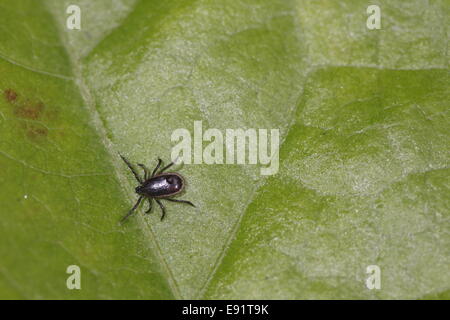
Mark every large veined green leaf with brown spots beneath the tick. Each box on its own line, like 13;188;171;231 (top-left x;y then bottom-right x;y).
0;0;450;299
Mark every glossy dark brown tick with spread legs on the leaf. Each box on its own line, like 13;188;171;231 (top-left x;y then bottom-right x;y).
119;154;195;222
